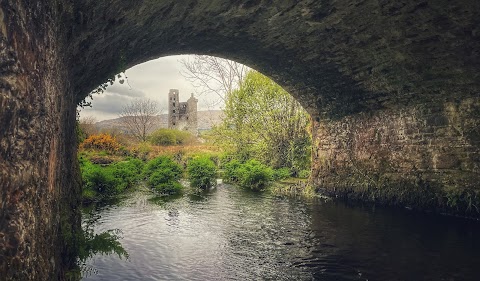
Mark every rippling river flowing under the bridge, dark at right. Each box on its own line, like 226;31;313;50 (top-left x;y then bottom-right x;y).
82;184;480;280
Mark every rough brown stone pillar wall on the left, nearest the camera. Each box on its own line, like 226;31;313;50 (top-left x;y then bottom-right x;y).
0;0;79;280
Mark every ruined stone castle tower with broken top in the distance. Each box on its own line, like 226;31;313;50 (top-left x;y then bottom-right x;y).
168;89;198;135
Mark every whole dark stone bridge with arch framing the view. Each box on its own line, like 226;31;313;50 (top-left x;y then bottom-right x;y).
0;0;480;280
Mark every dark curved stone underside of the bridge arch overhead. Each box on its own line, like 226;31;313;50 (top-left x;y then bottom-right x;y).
67;0;480;118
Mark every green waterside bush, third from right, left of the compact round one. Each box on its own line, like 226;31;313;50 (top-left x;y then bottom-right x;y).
143;156;182;195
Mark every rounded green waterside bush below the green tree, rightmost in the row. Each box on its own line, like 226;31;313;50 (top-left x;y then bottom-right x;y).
237;160;273;191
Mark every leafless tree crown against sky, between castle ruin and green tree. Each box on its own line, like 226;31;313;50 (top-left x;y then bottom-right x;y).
179;55;249;102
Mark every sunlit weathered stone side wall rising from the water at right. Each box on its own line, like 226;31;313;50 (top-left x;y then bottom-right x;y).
312;97;480;216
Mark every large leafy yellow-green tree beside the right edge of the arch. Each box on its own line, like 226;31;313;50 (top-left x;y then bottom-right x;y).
215;71;311;175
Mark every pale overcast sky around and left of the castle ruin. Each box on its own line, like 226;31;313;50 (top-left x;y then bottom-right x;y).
80;56;222;121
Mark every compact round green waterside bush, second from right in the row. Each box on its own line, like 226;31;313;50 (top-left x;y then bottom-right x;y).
187;156;217;189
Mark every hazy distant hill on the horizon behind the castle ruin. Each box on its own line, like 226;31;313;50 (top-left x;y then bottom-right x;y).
95;110;224;131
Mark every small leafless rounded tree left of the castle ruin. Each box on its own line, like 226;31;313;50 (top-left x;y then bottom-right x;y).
119;99;161;141
